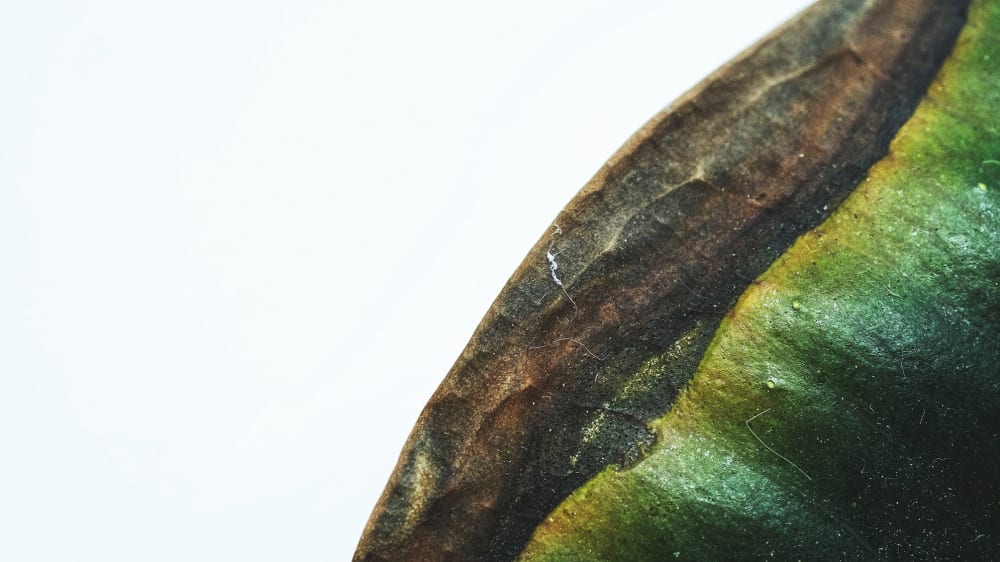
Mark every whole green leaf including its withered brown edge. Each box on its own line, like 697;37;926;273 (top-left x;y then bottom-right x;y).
355;0;1000;560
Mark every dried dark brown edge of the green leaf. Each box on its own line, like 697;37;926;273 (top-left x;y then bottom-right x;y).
355;0;969;561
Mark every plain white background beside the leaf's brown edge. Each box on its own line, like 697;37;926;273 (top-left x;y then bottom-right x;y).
0;0;807;562
